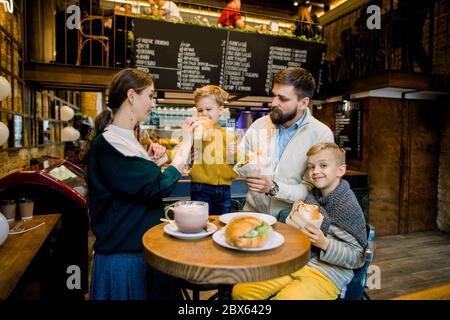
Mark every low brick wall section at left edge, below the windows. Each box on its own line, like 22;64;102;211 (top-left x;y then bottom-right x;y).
0;144;64;178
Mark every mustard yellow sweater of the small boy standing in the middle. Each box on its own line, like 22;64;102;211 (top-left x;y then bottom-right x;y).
190;124;237;186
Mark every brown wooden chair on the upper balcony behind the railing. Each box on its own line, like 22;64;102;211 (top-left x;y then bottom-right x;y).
77;16;109;67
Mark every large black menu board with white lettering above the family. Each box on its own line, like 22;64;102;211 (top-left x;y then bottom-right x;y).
134;19;325;96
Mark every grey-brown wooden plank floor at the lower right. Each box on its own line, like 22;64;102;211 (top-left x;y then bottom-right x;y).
367;231;450;300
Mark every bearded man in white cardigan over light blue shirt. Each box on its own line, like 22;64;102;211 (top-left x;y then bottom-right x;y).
239;68;334;218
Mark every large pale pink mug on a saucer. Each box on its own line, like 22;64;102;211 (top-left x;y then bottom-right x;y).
164;200;209;233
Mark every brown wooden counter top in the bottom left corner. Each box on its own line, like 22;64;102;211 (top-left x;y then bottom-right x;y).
0;214;61;300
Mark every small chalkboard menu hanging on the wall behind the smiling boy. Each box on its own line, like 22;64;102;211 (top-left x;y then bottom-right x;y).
334;101;362;160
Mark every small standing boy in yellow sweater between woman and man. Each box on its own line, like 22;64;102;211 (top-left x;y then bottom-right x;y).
190;85;237;215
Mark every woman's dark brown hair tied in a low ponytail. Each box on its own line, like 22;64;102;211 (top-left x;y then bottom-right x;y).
85;68;153;160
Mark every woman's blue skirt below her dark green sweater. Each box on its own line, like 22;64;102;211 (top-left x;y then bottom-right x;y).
90;253;182;300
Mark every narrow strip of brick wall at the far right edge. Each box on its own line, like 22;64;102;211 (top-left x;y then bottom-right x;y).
437;99;450;232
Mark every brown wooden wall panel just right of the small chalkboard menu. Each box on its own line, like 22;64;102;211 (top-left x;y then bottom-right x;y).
363;98;402;235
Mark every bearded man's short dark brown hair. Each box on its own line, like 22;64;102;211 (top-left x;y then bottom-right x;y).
273;67;316;99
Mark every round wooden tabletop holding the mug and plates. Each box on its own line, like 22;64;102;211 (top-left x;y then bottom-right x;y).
142;216;311;285
